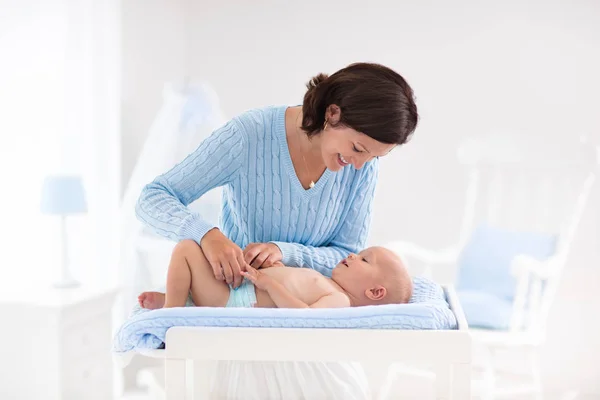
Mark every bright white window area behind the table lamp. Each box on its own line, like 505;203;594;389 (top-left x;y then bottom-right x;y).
0;0;120;284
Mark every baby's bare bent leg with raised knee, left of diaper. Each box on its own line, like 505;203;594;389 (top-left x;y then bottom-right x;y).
164;240;229;307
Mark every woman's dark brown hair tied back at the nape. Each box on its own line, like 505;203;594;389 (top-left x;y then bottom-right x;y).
302;63;419;144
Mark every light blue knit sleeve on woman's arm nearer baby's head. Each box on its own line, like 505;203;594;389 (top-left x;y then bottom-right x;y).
272;159;379;276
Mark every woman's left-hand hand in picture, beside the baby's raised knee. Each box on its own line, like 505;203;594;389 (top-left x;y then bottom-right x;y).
200;229;247;288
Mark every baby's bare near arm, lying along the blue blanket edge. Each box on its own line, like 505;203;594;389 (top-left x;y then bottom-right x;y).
242;267;350;308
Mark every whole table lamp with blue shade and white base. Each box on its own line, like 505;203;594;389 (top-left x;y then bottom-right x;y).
40;175;87;288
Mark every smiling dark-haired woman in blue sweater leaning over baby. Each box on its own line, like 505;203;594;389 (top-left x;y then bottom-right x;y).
136;63;418;287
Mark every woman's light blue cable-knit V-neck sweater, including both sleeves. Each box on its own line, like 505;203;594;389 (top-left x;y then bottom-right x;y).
136;106;378;276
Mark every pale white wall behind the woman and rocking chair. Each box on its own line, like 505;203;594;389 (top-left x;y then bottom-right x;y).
123;0;600;392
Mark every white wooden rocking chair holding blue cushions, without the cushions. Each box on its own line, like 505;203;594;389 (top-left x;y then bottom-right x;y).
388;133;599;399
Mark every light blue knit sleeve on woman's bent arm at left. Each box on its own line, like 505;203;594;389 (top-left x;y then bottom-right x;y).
135;120;247;242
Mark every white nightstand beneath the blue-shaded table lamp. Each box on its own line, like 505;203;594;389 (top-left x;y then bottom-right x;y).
0;287;117;400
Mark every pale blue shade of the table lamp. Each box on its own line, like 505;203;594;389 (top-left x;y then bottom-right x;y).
40;175;87;215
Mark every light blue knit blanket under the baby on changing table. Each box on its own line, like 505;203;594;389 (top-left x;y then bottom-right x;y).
113;278;457;354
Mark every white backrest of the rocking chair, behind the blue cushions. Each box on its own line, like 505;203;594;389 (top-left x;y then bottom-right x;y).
458;132;598;334
